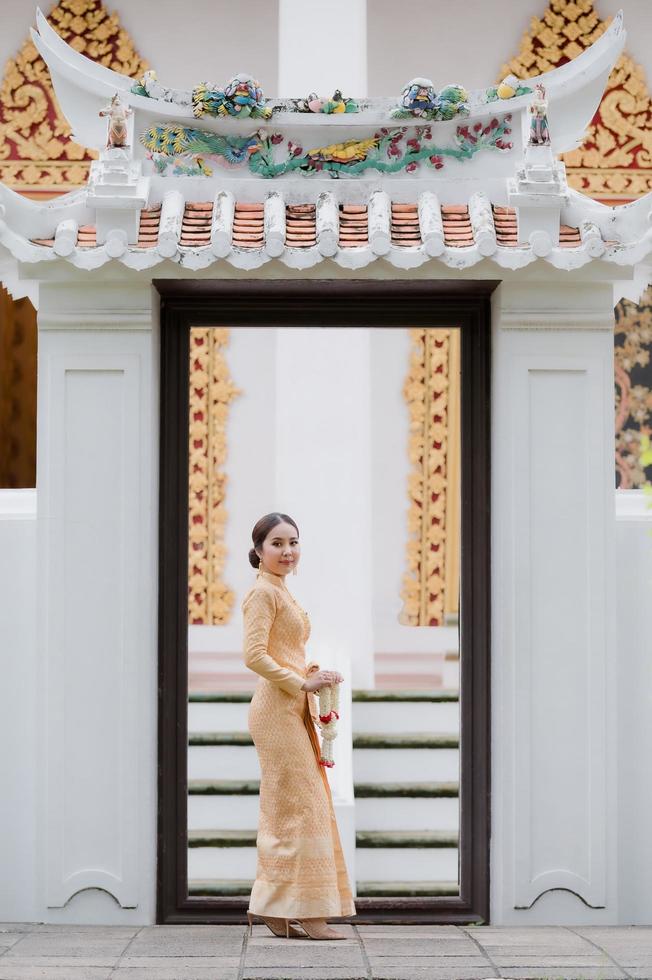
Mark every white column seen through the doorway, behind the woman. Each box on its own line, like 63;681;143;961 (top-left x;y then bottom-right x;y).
276;328;373;887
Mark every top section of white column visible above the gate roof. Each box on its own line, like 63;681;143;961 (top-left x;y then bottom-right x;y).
278;0;367;98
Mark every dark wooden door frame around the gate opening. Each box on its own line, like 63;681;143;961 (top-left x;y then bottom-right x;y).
154;280;498;924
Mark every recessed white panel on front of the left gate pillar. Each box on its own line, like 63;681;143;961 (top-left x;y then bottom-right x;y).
39;348;145;908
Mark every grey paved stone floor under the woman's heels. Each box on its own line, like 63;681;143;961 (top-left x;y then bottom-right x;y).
0;922;652;980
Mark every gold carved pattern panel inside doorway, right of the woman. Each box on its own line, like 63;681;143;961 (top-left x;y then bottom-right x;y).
399;328;457;626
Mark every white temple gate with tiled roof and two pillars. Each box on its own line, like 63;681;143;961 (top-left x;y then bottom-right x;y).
0;7;652;924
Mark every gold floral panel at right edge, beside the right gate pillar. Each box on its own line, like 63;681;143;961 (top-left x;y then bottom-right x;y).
615;286;652;490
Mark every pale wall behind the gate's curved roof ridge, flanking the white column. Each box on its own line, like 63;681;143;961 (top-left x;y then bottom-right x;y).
0;0;652;96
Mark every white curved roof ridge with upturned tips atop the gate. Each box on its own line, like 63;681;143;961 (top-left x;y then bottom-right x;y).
32;5;626;156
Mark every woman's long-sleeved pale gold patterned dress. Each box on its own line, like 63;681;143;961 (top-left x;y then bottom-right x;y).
241;571;356;919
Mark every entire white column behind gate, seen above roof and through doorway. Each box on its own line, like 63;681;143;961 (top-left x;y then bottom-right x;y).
276;0;373;892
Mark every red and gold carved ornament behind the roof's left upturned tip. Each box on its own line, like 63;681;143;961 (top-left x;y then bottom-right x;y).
0;0;149;196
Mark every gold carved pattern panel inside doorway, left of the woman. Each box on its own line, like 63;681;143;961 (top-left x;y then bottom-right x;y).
188;327;242;625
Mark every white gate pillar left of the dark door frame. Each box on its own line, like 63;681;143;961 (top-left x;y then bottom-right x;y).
35;280;158;923
